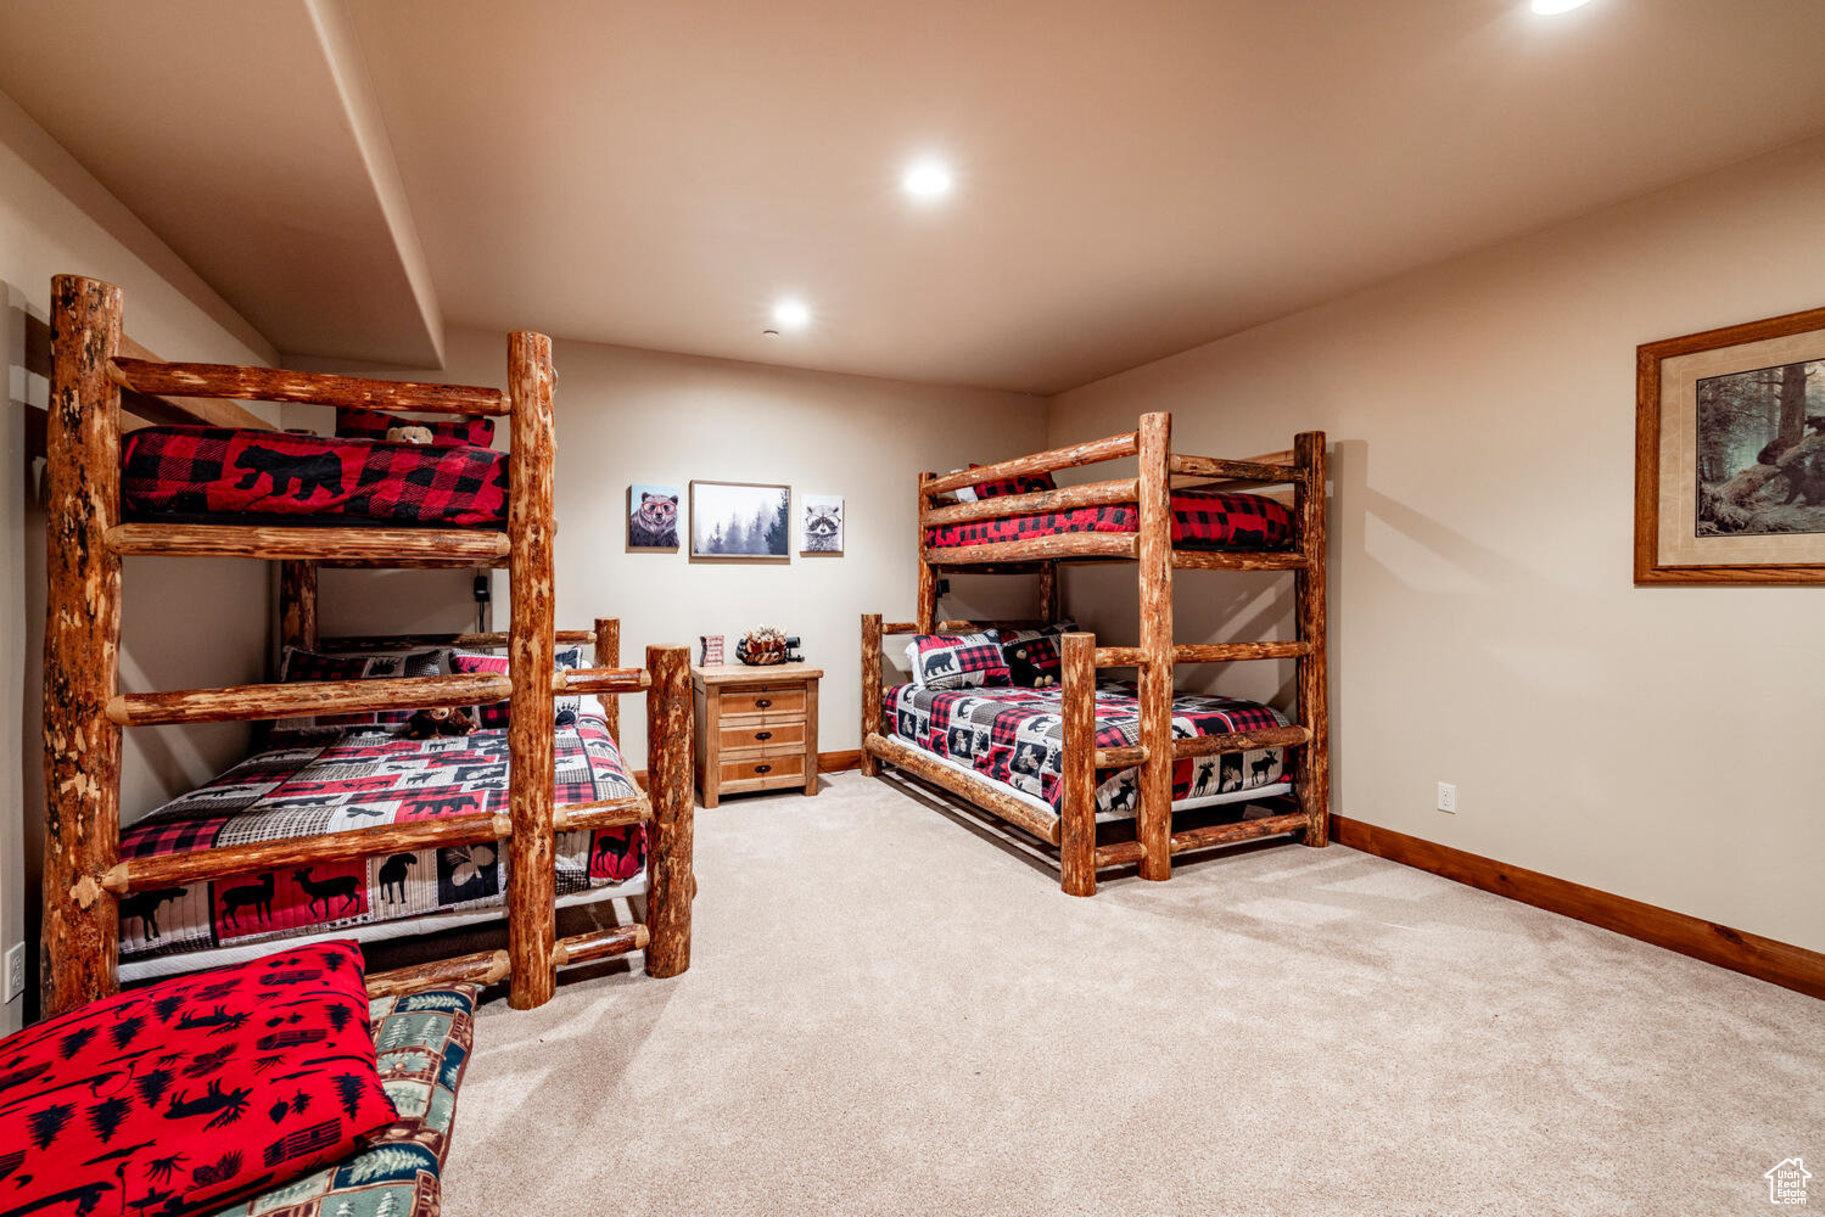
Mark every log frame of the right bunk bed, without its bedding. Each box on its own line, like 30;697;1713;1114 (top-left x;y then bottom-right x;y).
861;414;1330;896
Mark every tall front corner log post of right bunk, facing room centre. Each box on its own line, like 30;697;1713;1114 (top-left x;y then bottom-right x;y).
1135;414;1172;879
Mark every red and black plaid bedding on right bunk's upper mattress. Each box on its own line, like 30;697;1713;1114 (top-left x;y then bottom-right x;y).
925;491;1292;549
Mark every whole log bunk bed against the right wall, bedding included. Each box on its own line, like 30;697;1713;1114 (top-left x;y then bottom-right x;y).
861;414;1330;896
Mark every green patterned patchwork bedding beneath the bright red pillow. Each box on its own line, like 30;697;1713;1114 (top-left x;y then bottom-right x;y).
203;985;476;1217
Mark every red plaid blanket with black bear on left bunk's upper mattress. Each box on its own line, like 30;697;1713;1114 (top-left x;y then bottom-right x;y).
120;427;507;527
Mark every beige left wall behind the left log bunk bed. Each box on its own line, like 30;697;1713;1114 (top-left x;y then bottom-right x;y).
0;95;270;1031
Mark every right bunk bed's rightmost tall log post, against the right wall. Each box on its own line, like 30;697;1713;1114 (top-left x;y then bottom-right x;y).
1292;431;1330;845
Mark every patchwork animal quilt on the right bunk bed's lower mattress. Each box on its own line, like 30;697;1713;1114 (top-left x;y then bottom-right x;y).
881;681;1287;817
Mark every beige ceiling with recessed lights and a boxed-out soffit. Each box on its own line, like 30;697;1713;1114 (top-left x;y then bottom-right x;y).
0;0;1825;392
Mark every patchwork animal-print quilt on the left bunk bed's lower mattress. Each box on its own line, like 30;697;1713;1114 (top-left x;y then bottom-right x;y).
120;717;646;960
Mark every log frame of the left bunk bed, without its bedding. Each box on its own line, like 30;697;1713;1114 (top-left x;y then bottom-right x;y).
42;276;694;1016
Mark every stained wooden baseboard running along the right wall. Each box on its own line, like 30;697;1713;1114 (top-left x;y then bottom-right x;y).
1330;816;1825;998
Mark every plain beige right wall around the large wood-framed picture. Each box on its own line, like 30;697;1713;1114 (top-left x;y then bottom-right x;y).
1051;131;1825;949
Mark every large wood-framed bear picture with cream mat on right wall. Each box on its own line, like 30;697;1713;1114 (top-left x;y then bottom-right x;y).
1635;308;1825;584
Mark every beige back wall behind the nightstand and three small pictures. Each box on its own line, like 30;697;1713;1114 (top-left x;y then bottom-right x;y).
287;330;1046;765
